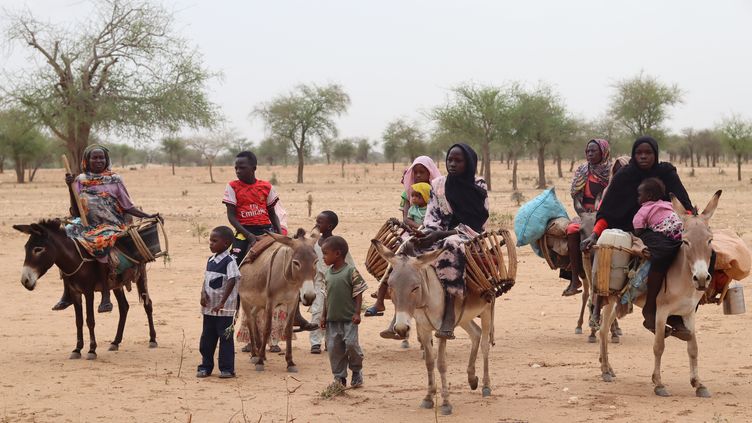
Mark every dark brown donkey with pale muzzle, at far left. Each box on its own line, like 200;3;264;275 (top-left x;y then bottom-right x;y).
13;219;157;360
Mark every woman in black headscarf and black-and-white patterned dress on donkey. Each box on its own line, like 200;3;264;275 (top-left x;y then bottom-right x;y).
417;144;488;339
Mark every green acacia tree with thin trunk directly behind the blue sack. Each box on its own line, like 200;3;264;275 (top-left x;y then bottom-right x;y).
515;85;571;189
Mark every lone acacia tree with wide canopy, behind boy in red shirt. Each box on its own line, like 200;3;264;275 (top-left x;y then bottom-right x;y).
252;84;350;184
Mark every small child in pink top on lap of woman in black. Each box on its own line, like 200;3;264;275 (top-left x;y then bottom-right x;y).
632;178;684;240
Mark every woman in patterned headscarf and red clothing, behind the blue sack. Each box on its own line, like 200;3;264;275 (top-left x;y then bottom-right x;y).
561;139;612;297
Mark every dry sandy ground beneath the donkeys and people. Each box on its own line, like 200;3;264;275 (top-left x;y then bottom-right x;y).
0;162;752;422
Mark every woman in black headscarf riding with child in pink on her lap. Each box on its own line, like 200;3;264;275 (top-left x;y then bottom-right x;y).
582;136;692;339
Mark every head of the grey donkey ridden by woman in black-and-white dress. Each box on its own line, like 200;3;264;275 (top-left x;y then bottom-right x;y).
371;239;444;336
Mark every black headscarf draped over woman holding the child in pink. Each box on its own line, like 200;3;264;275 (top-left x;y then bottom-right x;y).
597;137;692;231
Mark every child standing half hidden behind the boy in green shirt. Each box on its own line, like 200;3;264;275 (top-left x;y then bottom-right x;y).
308;210;355;354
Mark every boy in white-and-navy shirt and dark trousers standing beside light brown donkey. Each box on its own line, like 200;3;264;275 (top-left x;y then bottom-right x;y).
196;226;240;378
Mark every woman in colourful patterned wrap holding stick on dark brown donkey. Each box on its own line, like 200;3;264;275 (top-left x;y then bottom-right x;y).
52;144;159;313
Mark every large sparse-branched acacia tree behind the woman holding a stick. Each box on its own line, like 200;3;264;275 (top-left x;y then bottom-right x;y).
2;0;216;171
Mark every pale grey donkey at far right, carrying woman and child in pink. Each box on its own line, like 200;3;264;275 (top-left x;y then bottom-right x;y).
600;191;721;398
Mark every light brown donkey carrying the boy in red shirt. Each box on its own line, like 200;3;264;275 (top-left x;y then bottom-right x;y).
238;229;318;373
